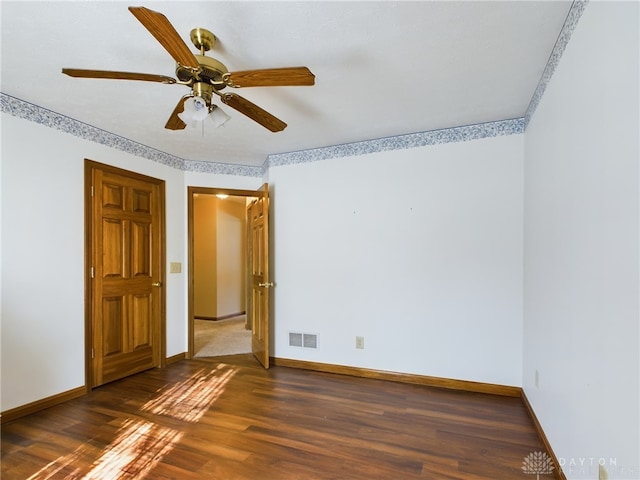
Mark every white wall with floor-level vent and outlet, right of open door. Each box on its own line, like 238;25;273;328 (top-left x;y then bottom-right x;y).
269;135;523;385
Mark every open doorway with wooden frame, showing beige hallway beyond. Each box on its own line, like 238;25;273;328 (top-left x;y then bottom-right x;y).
188;187;257;358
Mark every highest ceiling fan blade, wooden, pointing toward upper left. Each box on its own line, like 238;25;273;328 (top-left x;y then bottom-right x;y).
129;7;200;69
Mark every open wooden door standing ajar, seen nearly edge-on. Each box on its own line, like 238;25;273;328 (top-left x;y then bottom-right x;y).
247;183;273;368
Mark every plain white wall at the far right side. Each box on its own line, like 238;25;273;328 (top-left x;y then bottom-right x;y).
523;2;640;479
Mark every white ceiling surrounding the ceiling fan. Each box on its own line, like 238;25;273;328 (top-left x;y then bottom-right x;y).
0;1;571;166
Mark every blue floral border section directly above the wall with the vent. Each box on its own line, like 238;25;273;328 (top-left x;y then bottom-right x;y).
265;118;524;168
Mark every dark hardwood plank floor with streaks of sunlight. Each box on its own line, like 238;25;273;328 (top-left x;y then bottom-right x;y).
1;355;551;480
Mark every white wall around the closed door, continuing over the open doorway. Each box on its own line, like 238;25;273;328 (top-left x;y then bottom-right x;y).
0;113;261;411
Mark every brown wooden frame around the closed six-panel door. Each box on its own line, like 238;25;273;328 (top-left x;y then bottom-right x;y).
84;158;167;393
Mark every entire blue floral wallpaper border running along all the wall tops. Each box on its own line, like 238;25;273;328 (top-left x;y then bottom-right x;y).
0;0;589;177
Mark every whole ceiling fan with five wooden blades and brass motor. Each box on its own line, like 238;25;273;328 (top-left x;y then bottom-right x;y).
62;7;315;132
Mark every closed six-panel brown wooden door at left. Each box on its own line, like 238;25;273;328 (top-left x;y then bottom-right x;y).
89;164;164;386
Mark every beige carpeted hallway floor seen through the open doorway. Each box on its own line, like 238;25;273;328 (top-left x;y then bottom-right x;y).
194;315;251;357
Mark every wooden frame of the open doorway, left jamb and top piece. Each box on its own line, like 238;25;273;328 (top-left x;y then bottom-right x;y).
186;187;263;358
